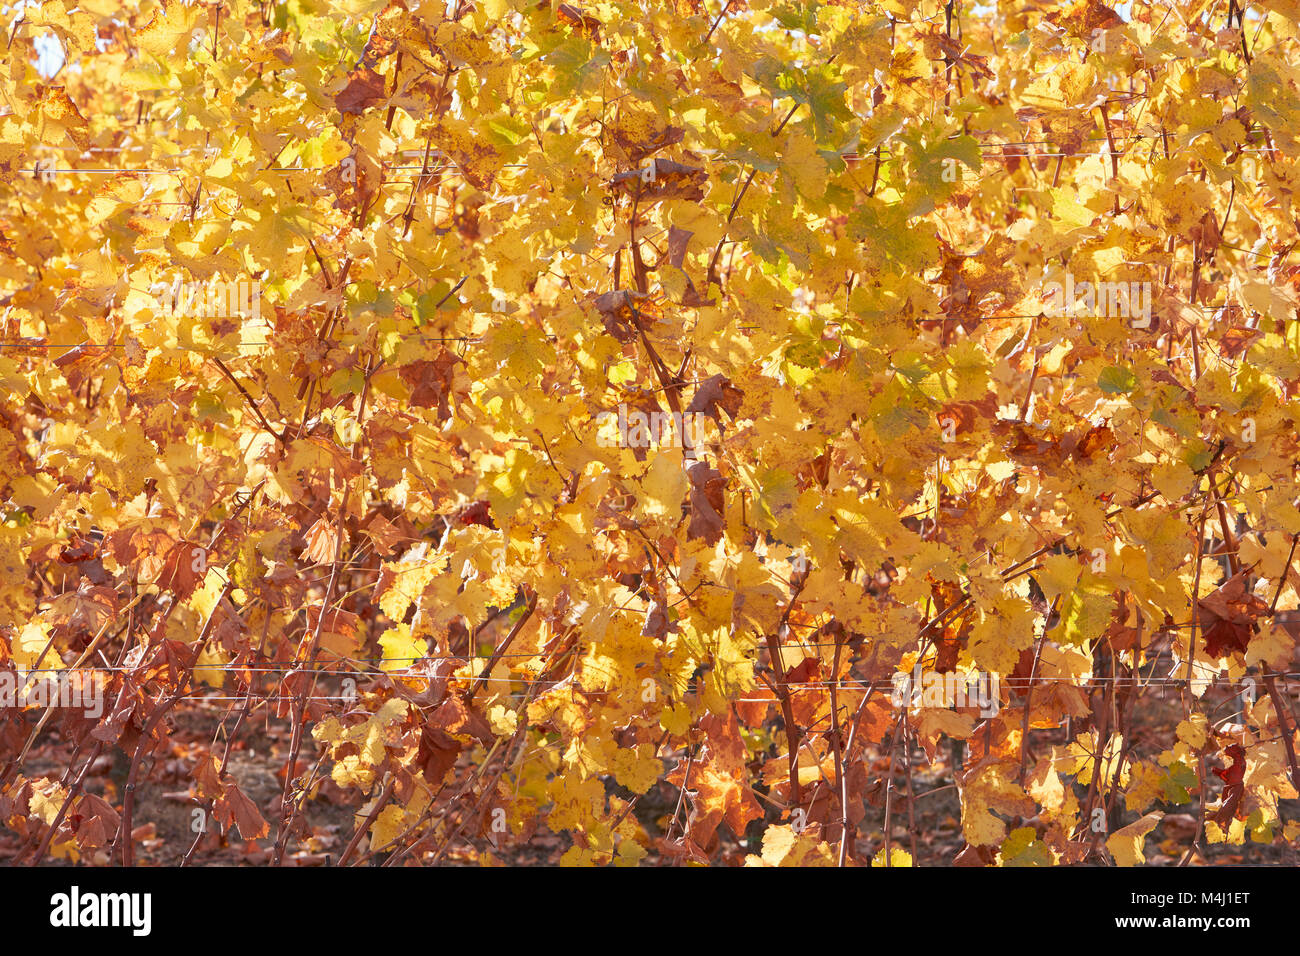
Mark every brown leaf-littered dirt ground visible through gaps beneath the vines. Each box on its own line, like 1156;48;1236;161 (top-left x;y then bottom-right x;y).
0;671;1300;866
